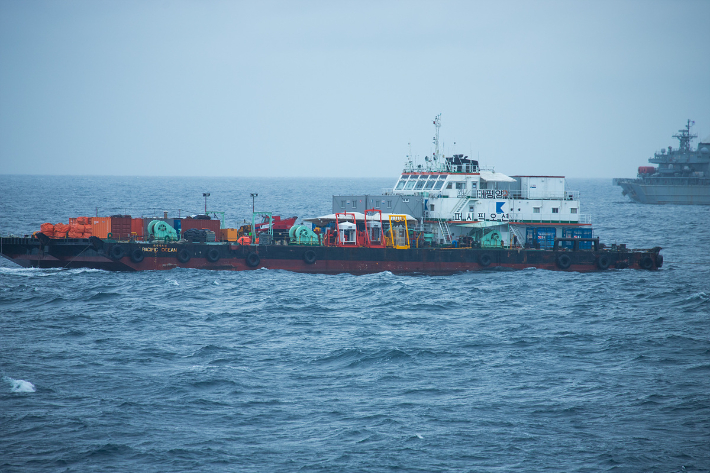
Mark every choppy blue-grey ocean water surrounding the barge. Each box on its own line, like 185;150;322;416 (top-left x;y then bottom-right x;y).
0;175;710;473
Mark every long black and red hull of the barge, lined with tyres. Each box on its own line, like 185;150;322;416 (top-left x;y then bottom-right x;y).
3;239;663;275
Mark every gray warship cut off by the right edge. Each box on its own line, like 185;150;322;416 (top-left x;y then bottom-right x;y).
613;120;710;205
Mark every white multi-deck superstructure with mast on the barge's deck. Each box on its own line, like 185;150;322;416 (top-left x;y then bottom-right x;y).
387;116;591;247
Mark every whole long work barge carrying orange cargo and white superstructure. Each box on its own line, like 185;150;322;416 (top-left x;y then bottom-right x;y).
0;115;663;274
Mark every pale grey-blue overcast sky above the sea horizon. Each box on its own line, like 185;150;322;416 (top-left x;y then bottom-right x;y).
0;0;710;178
